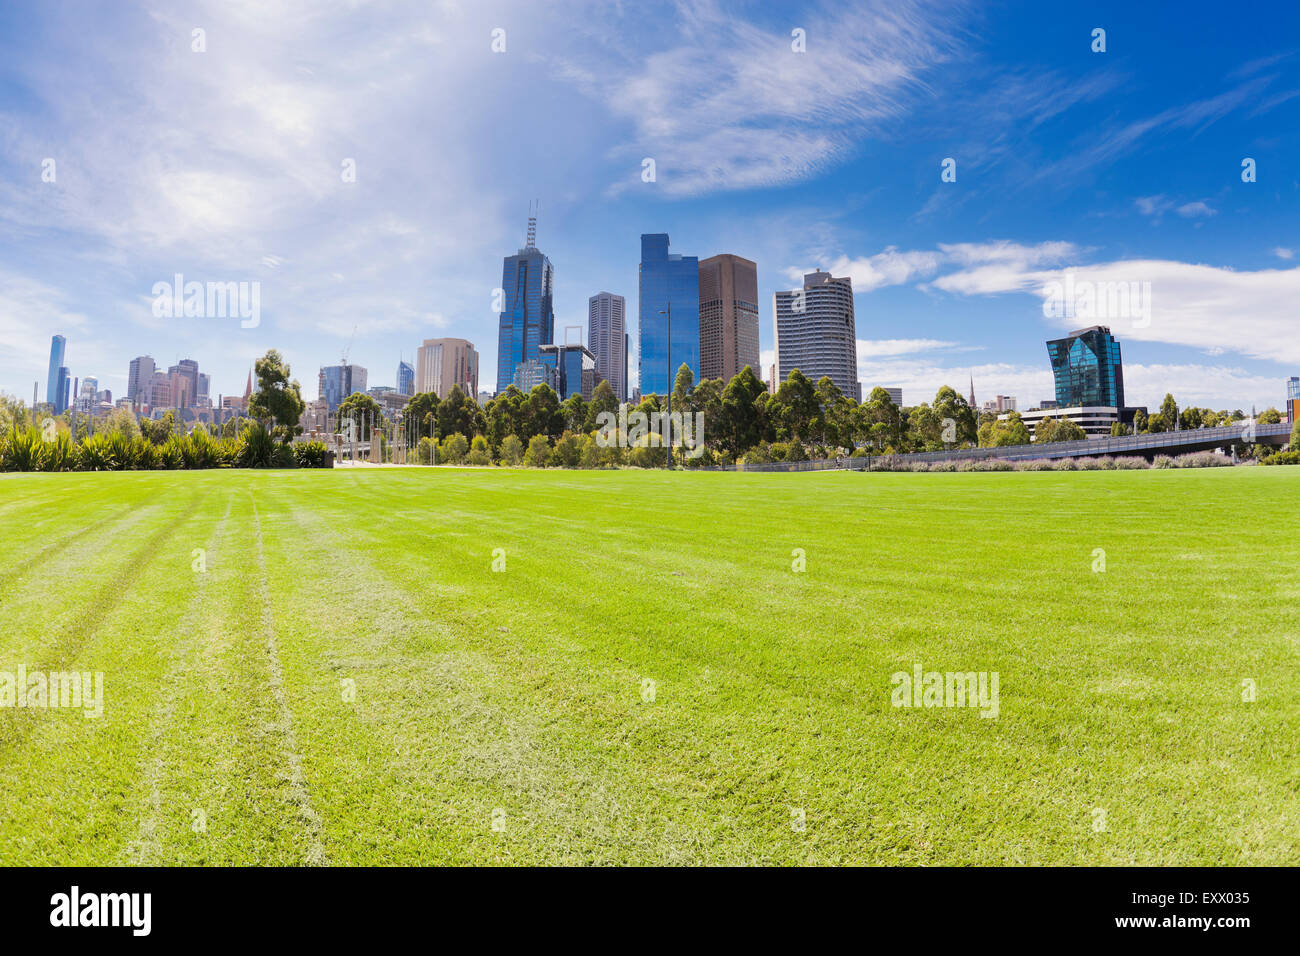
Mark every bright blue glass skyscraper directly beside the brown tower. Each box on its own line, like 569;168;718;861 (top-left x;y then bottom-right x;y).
637;233;699;395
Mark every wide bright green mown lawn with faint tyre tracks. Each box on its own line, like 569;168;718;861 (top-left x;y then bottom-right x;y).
0;468;1300;865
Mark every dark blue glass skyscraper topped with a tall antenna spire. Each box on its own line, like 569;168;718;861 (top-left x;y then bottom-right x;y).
496;216;555;393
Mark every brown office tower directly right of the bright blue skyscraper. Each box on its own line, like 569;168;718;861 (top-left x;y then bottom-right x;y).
699;254;762;382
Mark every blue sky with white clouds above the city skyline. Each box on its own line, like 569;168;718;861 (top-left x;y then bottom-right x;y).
0;0;1300;408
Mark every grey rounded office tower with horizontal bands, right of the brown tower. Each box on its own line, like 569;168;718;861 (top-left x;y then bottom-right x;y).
772;269;859;398
